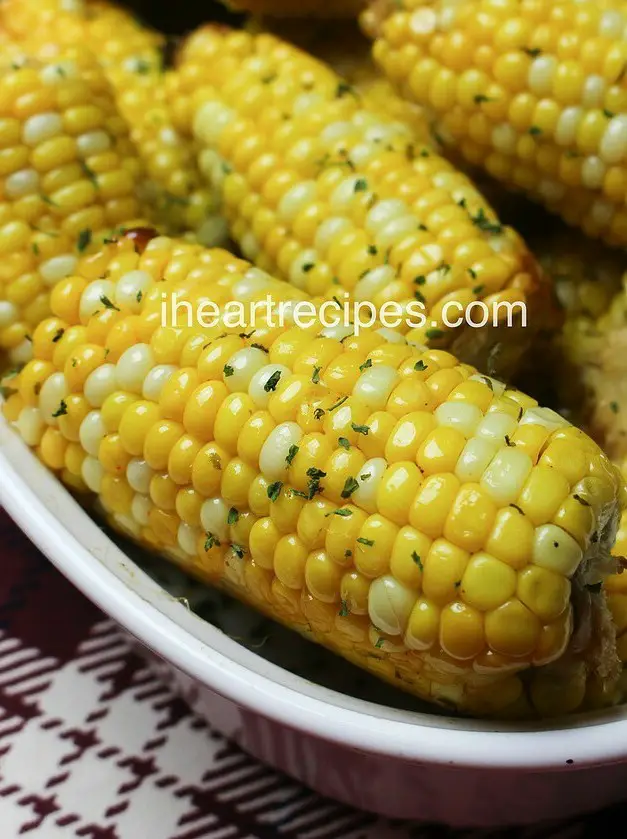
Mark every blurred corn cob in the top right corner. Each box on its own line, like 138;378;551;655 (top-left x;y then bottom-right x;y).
364;0;627;246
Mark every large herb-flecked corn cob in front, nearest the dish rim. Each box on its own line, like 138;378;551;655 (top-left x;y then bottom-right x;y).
5;226;622;716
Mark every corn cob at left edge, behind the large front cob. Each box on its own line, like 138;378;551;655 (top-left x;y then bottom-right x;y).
0;45;145;363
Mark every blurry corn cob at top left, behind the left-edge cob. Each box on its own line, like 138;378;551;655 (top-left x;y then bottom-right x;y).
3;0;225;245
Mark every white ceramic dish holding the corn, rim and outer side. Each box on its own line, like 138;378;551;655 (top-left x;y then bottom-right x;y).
0;420;627;826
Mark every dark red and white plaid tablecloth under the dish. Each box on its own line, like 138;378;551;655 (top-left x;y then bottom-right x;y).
0;511;627;839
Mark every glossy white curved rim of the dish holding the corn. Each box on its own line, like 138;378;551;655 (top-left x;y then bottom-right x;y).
0;417;627;771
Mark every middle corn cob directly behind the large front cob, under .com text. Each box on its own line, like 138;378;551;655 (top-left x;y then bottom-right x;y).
172;27;550;372
